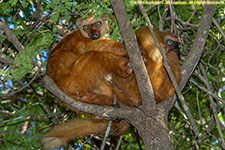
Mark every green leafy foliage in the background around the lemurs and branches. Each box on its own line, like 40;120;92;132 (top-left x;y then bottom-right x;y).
0;0;225;150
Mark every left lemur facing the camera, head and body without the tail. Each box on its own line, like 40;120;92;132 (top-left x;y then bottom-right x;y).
46;14;132;111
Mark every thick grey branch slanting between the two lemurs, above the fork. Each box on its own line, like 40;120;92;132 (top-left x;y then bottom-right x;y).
111;0;156;110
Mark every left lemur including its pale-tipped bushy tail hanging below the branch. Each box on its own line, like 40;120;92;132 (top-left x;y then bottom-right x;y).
40;15;132;150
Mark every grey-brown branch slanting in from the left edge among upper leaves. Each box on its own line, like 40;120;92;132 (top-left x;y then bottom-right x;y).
0;21;24;52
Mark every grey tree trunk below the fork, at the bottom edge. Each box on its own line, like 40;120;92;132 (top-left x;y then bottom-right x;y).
132;107;173;150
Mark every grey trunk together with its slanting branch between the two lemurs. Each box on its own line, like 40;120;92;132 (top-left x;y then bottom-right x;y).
111;0;173;149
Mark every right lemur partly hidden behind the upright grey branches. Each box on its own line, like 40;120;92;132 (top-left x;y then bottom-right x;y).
114;26;181;106
